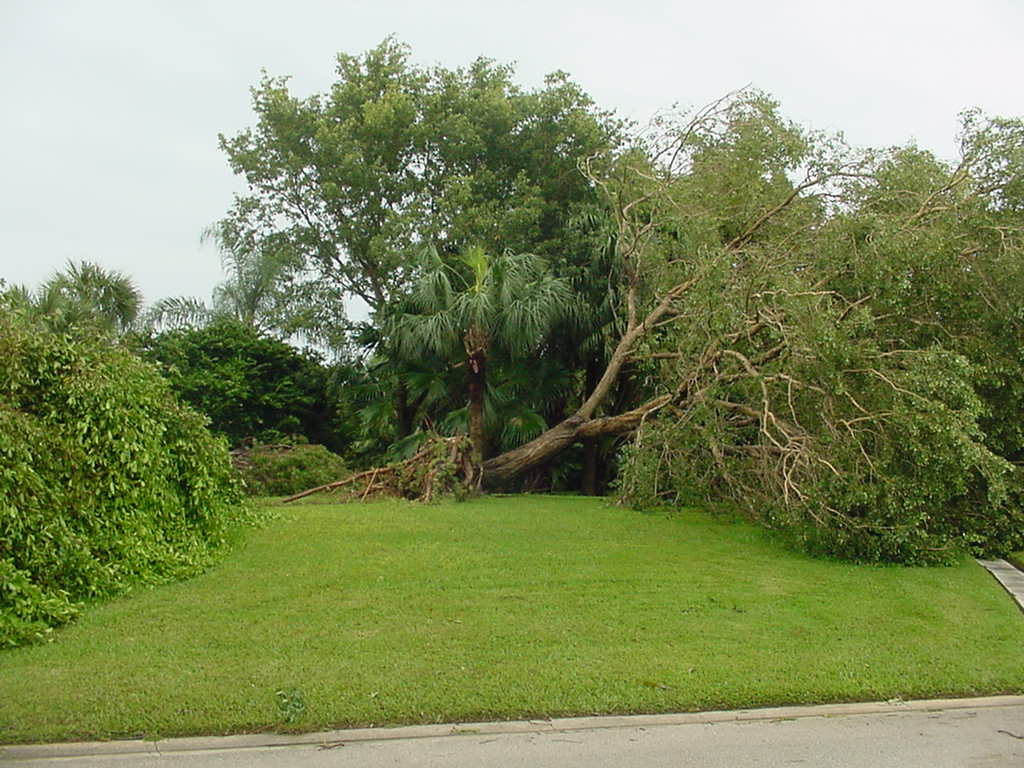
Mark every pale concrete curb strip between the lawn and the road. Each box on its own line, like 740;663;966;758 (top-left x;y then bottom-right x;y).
0;695;1024;763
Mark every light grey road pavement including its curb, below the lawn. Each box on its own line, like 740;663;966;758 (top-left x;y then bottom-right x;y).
0;696;1024;768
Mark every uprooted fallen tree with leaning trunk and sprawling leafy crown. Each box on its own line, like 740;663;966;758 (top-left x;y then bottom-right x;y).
282;93;1024;562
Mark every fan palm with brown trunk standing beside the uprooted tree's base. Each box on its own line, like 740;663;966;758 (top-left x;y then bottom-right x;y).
387;246;573;461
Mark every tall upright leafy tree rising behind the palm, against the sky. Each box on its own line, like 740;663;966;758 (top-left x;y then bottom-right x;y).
218;39;621;438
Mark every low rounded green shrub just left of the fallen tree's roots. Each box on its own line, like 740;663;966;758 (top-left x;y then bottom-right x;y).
234;444;349;496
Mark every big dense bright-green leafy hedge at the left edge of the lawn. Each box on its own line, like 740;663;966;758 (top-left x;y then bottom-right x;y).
0;310;247;647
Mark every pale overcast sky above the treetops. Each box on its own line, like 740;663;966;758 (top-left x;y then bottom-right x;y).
0;0;1024;309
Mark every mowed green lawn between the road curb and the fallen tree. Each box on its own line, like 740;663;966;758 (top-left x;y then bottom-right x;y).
0;497;1024;742
